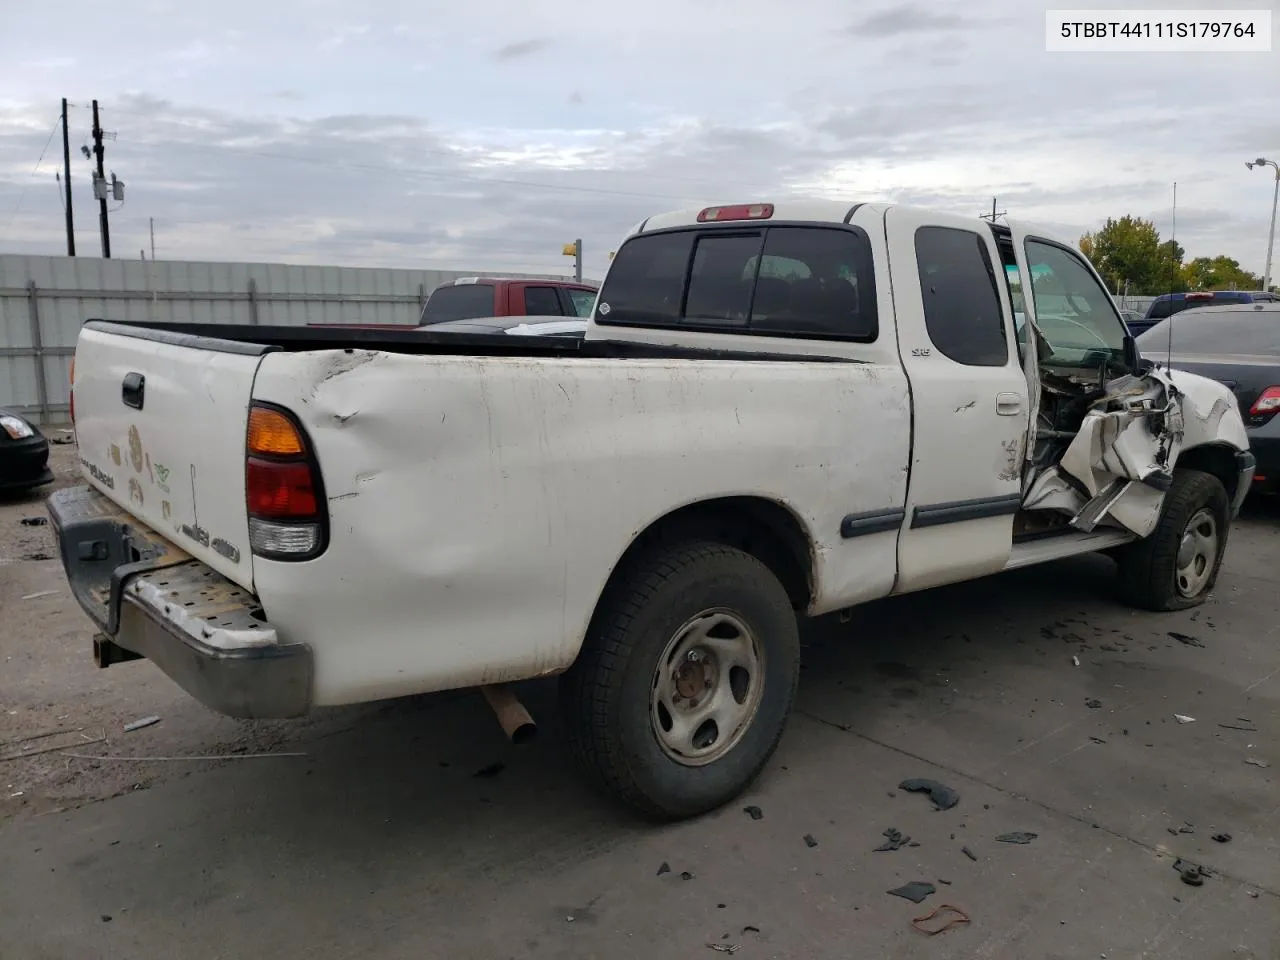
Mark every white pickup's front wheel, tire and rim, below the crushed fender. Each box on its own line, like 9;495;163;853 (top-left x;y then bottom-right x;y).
1116;470;1230;612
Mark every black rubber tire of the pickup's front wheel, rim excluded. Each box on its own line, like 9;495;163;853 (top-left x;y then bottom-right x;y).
1116;470;1231;612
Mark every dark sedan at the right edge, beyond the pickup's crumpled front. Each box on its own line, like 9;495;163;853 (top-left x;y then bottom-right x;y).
1137;302;1280;493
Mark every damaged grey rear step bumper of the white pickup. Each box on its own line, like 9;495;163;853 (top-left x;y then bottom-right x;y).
47;486;314;719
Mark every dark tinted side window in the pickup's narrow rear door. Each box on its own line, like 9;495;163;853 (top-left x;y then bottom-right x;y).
915;227;1009;366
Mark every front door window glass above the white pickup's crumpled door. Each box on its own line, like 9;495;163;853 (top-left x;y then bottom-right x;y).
1025;239;1125;367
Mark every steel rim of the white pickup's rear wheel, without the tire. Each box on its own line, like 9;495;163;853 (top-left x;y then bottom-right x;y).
649;609;764;767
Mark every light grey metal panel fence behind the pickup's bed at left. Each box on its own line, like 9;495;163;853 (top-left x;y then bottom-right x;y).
0;253;568;424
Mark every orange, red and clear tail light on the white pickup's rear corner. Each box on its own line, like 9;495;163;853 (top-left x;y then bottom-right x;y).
244;403;329;561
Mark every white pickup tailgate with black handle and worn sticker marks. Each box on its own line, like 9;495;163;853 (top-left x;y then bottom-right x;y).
74;321;270;589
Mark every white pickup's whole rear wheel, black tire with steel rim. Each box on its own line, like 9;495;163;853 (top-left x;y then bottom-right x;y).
561;543;800;819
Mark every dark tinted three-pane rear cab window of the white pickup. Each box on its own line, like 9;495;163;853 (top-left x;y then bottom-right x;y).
596;227;877;342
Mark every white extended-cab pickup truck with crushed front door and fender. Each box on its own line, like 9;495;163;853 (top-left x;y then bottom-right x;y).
49;201;1253;818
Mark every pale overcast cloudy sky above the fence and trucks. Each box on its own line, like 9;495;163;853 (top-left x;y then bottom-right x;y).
0;0;1280;276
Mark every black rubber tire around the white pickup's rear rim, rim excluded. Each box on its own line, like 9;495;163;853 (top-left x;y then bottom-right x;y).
561;541;800;819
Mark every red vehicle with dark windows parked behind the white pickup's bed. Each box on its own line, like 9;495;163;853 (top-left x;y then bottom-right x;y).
419;276;596;325
